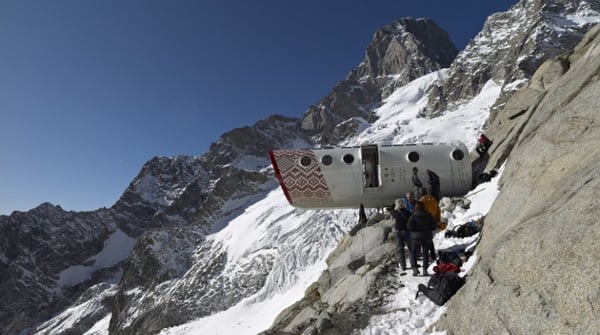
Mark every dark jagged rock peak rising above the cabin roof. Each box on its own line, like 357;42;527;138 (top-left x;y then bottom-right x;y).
302;19;458;145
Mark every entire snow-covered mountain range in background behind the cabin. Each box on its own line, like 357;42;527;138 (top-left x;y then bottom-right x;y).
0;0;600;334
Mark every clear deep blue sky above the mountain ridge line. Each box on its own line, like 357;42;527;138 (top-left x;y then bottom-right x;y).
0;0;517;214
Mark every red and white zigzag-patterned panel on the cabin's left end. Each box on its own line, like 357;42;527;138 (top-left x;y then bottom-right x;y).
271;150;333;206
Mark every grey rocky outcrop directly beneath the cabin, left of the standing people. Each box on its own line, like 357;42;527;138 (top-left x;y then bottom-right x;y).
262;217;402;335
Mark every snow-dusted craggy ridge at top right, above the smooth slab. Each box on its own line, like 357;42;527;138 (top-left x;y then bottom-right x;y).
424;0;600;120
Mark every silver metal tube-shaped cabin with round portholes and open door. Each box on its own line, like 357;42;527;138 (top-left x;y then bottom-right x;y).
269;143;471;209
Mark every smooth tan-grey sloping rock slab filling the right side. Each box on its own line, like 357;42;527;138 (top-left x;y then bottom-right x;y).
437;26;600;334
